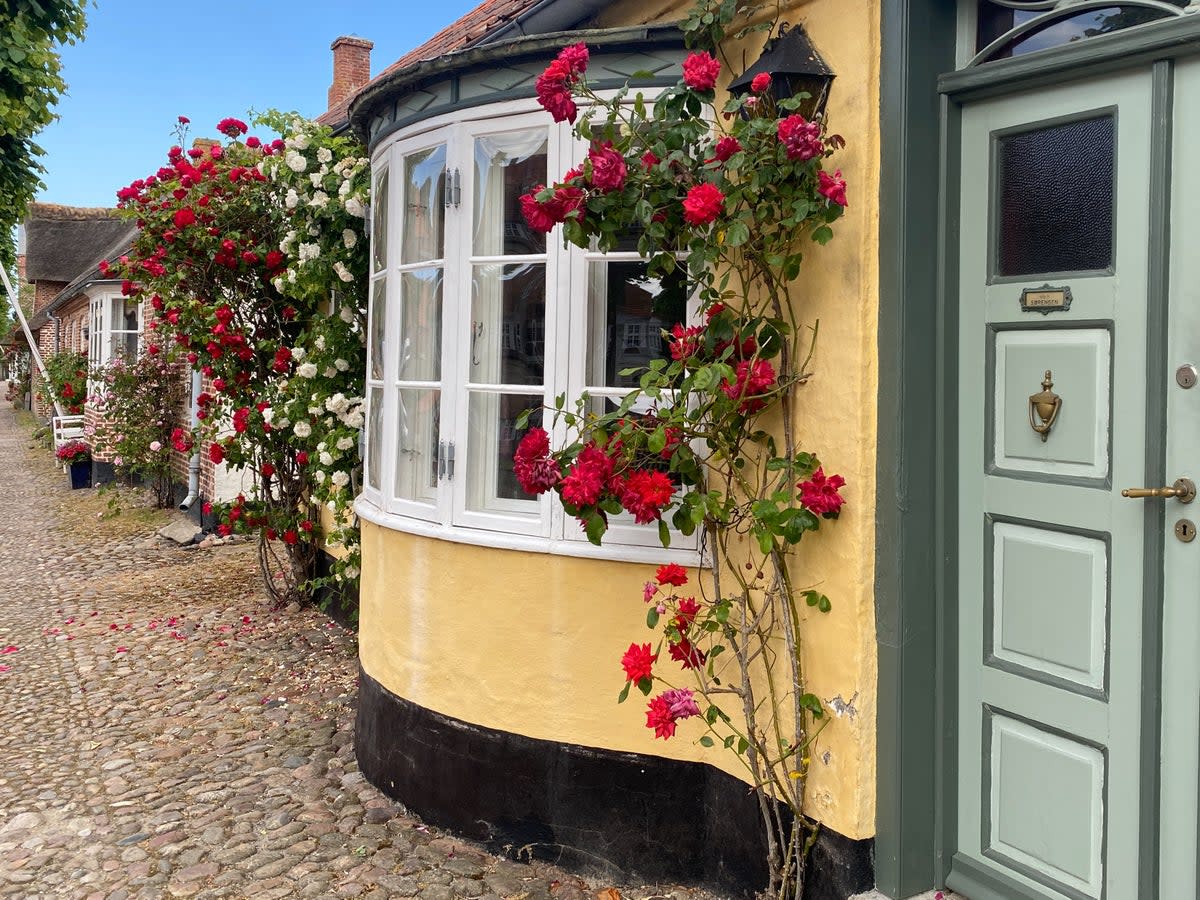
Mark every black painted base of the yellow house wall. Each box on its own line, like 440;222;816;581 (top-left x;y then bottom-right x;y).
355;672;875;900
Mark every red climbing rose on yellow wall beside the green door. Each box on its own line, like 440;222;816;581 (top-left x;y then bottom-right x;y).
514;0;847;898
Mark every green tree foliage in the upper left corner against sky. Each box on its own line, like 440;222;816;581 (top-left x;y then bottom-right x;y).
0;0;86;265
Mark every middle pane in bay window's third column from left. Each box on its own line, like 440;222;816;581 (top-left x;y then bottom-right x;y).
470;263;546;384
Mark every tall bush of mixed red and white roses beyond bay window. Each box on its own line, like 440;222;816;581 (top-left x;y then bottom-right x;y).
105;113;368;602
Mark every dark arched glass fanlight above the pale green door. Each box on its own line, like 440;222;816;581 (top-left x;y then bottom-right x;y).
970;0;1200;66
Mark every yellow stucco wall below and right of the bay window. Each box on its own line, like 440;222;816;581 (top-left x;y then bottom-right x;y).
360;0;880;839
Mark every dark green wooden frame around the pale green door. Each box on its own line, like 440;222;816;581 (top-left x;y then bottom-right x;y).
875;8;1200;898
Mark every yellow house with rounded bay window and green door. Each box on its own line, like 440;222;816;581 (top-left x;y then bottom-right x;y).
348;0;1200;900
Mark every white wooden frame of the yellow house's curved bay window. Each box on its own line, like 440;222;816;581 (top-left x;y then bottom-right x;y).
356;101;698;564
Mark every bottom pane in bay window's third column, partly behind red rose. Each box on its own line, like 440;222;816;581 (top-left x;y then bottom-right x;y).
466;391;542;515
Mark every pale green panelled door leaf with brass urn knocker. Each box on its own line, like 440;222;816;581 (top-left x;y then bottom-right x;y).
949;67;1156;900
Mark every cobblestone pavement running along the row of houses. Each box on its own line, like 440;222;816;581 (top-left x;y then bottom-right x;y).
0;409;712;900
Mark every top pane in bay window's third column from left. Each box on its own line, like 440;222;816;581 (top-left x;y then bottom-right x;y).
473;128;546;257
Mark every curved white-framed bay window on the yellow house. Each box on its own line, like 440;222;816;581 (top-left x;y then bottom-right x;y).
362;106;695;557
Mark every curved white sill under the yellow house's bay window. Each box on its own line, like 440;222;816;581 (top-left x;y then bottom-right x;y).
354;494;702;566
